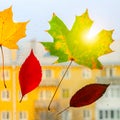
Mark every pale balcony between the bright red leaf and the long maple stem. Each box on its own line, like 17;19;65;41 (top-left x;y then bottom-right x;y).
40;78;59;86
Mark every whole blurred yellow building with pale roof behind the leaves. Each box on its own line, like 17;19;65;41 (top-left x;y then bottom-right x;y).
0;41;120;120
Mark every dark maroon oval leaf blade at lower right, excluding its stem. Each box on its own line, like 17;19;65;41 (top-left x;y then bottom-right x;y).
70;84;109;107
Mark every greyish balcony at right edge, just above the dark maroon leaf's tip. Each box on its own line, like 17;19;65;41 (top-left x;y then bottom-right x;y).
96;76;120;85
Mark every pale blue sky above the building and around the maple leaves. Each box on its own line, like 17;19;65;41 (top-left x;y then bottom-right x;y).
0;0;120;64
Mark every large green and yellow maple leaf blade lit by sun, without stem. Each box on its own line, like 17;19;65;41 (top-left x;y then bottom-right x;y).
41;10;113;69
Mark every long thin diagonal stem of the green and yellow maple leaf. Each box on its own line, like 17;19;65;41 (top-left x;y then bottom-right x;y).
48;60;73;111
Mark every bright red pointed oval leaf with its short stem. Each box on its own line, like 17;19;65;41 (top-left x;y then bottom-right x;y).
19;50;42;101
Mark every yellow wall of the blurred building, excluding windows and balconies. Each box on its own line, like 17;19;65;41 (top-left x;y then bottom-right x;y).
0;65;104;120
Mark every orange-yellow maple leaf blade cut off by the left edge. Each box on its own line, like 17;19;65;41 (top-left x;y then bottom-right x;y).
0;7;28;49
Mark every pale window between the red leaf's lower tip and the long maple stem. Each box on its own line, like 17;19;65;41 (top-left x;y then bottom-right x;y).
40;90;52;100
